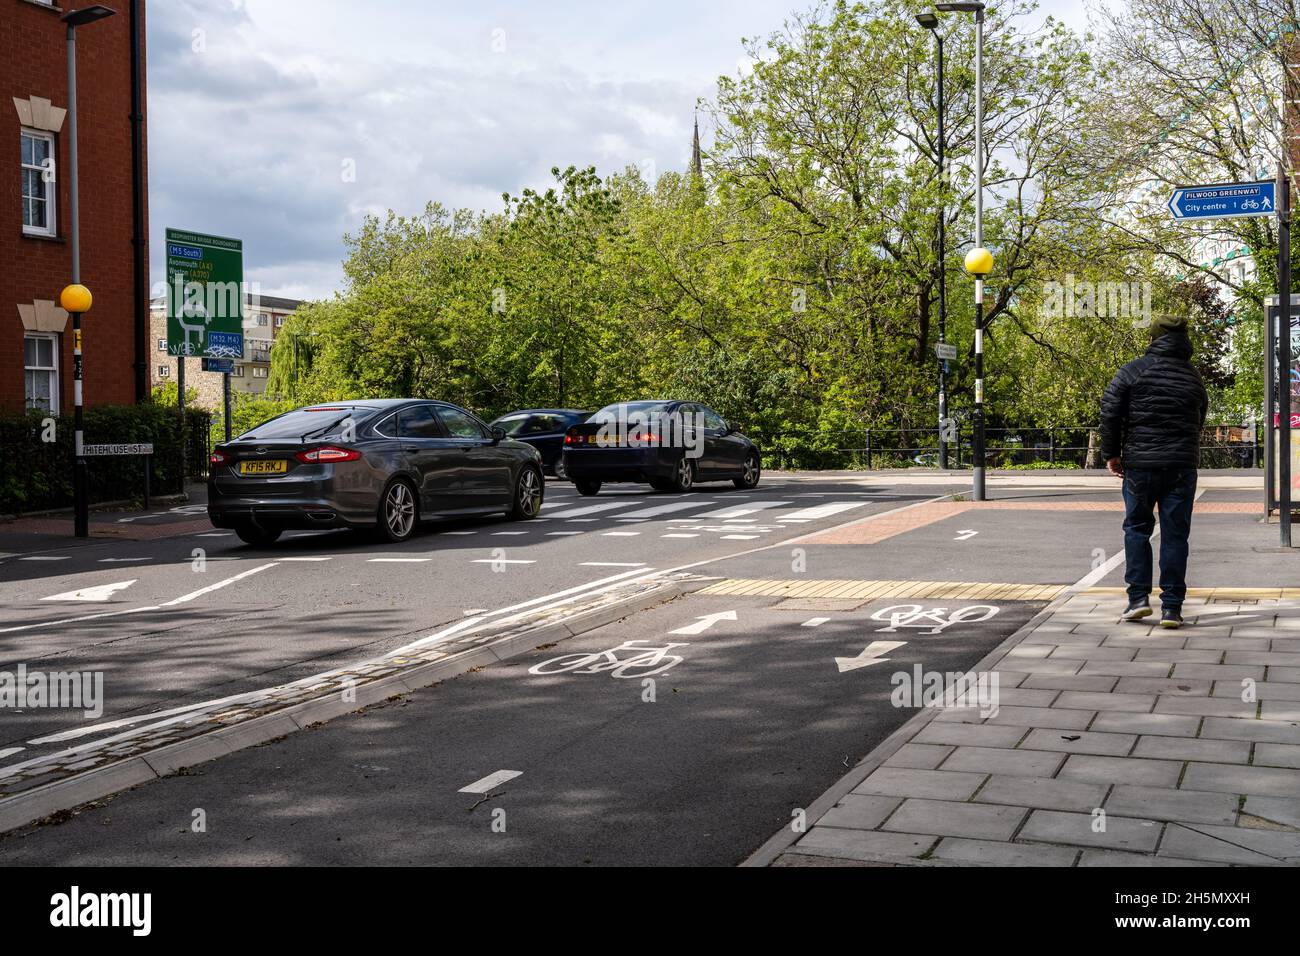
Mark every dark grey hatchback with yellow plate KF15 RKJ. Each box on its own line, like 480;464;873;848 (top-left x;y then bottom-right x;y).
208;398;545;545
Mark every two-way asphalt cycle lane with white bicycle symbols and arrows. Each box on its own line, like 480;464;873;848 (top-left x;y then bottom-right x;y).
0;596;1040;865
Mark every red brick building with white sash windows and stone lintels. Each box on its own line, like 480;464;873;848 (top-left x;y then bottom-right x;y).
0;0;150;414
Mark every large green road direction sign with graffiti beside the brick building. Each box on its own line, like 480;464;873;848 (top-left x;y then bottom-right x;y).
166;229;243;359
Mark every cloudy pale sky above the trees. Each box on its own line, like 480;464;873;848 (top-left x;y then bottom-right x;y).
148;0;1107;298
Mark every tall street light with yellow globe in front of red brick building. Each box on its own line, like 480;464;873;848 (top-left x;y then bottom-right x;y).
59;4;114;537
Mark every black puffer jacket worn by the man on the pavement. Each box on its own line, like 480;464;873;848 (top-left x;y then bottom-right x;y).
1101;332;1209;468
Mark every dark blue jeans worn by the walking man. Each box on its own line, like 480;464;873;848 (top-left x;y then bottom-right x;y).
1125;467;1196;611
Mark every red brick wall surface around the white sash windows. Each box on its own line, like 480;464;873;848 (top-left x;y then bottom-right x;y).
0;0;151;411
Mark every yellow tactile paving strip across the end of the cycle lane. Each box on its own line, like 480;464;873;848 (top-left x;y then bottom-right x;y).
698;578;1071;602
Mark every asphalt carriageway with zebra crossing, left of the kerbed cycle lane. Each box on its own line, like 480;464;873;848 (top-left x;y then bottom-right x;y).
0;476;944;767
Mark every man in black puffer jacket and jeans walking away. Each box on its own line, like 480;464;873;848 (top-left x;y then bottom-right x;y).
1101;316;1209;627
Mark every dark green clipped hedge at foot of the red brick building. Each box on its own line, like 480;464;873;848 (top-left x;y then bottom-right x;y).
0;402;209;514
